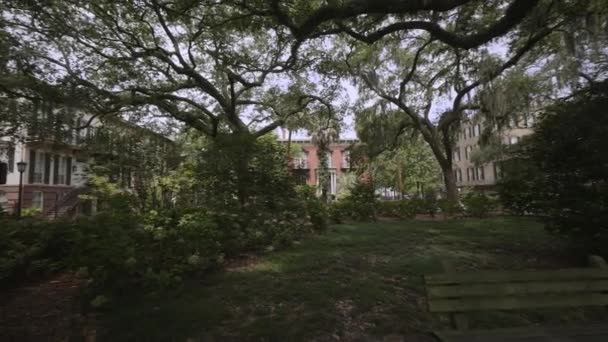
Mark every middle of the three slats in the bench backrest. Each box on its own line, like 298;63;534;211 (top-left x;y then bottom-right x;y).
427;280;608;299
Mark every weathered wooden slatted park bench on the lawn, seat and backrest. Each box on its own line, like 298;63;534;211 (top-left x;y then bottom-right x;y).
424;256;608;342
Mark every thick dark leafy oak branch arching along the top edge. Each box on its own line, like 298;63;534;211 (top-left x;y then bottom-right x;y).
245;0;540;49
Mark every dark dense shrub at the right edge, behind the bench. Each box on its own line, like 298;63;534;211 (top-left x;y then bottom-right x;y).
501;81;608;245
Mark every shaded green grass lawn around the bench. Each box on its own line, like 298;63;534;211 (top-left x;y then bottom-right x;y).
102;218;605;341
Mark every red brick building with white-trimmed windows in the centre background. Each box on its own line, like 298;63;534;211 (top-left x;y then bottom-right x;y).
283;139;358;196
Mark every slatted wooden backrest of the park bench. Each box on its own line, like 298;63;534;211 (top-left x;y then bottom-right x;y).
424;268;608;313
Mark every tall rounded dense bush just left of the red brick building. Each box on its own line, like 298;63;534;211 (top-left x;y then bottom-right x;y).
173;134;318;250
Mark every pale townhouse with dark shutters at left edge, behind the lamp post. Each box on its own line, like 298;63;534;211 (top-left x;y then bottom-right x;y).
0;110;92;212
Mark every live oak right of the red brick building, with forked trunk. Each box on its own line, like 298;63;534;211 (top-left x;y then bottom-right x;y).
298;1;600;201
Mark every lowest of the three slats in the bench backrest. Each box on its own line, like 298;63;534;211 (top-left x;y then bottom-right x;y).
428;293;608;312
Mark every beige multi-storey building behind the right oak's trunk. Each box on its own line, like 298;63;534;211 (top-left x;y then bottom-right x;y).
452;116;534;188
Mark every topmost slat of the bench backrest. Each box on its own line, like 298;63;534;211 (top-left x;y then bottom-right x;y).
424;268;608;285
